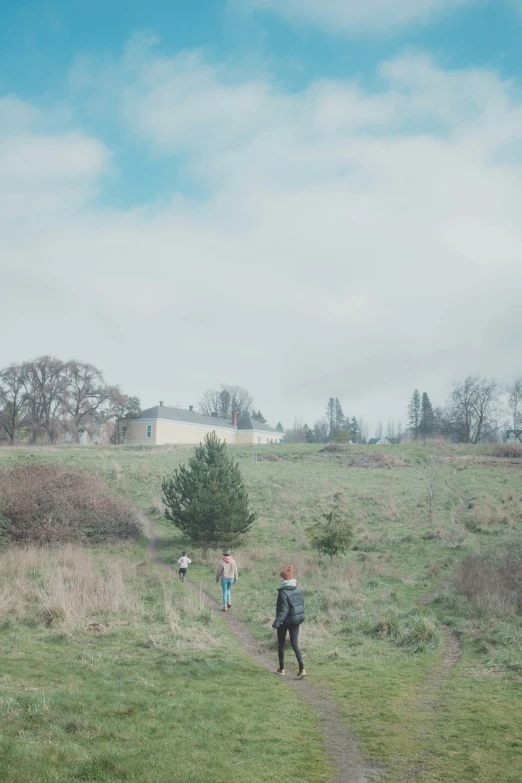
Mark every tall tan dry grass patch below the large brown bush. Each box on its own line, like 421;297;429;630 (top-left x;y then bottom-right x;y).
0;544;217;650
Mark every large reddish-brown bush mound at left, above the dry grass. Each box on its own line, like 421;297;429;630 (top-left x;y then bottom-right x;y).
0;463;141;543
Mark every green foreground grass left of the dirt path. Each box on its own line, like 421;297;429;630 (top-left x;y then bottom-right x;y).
0;544;329;783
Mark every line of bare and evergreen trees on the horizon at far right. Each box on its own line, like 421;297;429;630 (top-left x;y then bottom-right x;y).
408;374;522;443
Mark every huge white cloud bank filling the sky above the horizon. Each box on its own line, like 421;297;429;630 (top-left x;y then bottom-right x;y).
0;48;522;434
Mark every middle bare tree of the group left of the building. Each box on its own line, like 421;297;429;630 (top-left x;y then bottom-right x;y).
22;356;67;443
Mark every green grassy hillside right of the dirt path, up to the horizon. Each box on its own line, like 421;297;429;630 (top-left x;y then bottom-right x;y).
0;446;522;783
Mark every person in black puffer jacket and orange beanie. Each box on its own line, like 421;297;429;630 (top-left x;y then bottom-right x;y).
272;566;306;680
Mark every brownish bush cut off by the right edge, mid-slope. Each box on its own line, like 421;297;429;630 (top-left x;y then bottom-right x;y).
455;544;522;614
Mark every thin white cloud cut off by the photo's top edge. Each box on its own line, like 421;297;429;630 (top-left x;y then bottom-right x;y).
238;0;476;33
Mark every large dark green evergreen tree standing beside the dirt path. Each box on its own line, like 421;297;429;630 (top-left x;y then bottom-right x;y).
162;432;257;549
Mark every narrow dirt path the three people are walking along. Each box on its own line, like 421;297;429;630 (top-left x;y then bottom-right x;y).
136;509;383;783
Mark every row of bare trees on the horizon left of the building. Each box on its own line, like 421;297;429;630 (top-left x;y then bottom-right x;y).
0;356;134;444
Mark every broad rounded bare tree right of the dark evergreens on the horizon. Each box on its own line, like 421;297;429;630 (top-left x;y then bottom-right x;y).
447;375;502;443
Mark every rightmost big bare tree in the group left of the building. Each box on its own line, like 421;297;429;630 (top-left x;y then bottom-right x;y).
61;360;125;443
